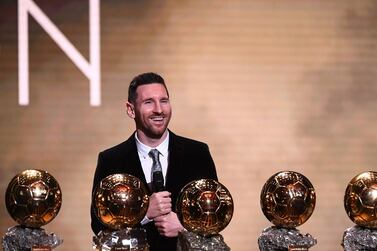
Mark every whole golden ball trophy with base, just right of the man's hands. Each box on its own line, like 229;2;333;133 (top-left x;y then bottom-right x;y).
176;179;233;251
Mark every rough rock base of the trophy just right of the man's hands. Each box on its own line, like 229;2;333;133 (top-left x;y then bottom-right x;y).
177;230;230;251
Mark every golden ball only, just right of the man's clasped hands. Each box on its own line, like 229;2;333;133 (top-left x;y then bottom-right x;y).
176;179;233;236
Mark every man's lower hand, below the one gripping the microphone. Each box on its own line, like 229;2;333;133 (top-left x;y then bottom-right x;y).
154;212;183;237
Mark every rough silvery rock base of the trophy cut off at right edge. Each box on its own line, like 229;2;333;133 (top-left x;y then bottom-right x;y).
341;226;377;251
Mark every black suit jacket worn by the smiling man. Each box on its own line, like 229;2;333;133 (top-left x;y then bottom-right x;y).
91;131;217;251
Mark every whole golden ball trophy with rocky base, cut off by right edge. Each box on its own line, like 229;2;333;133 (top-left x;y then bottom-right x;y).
342;171;377;251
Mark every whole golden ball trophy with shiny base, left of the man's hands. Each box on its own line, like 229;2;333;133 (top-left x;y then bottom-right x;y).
93;174;149;251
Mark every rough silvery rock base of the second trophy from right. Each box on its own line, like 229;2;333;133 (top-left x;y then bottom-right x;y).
258;226;317;251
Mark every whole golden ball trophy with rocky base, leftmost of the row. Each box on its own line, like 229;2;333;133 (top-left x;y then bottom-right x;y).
3;169;63;251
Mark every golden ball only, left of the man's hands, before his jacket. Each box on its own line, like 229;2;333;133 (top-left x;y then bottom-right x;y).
94;174;149;230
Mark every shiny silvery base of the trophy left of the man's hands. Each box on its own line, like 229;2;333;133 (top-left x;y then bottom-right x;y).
93;228;149;251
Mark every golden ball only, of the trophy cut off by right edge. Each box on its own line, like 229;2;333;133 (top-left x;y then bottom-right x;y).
344;171;377;229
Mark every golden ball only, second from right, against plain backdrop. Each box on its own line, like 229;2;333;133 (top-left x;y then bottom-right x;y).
260;171;316;228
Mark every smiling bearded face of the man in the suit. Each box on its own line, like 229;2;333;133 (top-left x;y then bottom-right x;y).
127;83;171;139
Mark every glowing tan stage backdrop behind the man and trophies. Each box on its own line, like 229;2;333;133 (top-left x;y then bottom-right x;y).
0;0;377;251
